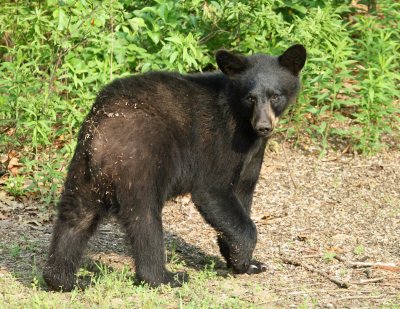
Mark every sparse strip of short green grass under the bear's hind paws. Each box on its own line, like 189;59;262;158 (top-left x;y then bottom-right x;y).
0;267;274;308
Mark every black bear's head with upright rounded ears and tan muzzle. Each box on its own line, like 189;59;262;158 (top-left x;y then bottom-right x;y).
216;44;307;137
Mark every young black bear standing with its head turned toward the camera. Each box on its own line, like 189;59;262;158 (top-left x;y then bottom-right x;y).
43;45;306;291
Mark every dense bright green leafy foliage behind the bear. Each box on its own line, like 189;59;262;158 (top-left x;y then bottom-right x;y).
0;0;400;201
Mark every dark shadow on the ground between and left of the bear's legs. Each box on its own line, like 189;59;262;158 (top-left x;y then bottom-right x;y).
0;221;231;290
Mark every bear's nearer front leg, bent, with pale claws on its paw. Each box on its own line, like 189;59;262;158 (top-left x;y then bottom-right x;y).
192;190;266;274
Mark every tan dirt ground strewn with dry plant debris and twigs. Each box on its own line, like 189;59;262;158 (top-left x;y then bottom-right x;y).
0;144;400;308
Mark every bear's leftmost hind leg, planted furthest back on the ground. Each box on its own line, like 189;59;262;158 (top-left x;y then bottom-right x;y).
43;194;101;291
